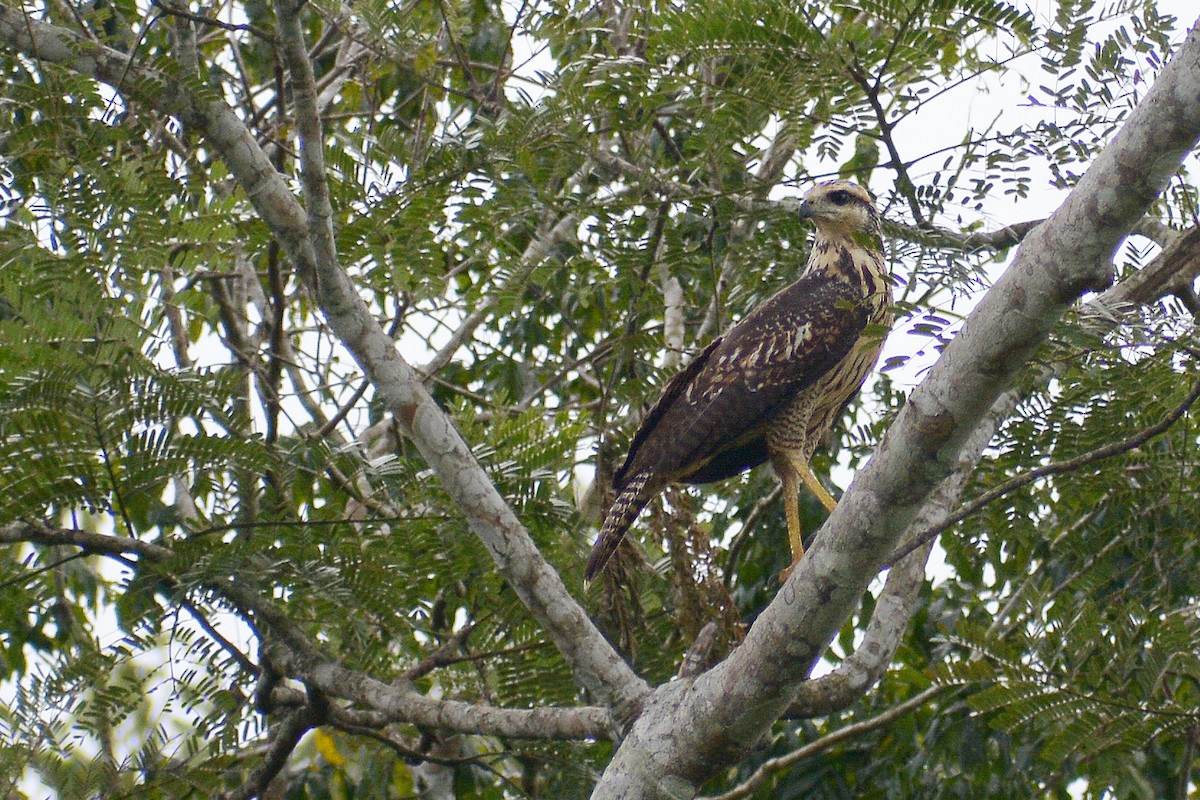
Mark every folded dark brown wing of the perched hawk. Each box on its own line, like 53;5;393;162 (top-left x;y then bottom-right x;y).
613;273;866;492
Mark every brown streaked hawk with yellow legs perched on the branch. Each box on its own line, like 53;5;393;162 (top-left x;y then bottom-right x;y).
584;181;892;581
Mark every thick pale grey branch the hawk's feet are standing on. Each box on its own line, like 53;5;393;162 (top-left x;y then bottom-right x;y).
593;15;1200;799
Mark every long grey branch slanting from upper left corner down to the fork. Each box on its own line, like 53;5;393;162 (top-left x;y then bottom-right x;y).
0;6;647;717
